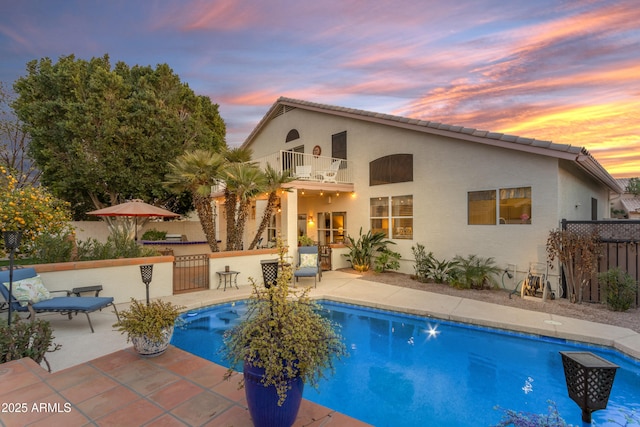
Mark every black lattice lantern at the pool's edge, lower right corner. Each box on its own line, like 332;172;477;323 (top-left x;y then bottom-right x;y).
560;351;618;423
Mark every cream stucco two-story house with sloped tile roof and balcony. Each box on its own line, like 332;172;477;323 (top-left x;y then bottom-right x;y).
243;98;622;286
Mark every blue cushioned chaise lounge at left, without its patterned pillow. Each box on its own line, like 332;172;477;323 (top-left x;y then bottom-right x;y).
0;267;120;332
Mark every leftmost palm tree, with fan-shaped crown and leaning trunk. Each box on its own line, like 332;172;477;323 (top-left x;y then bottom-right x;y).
164;150;225;252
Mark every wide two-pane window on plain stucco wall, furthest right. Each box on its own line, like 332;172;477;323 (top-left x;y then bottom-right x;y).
467;187;531;225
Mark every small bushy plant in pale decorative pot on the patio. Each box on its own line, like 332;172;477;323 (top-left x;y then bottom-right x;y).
113;298;183;357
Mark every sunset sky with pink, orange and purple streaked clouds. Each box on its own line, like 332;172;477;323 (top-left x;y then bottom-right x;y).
0;0;640;178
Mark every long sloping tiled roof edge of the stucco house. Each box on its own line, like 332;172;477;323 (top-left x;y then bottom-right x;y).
242;97;624;193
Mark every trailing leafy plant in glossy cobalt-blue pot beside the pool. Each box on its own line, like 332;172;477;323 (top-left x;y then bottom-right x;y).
223;238;346;427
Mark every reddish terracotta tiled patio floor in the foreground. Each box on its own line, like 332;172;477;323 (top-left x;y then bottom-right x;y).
0;346;367;427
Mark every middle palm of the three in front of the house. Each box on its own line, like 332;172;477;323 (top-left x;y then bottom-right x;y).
224;163;266;251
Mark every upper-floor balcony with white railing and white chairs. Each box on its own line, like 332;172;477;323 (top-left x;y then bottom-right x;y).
253;150;353;184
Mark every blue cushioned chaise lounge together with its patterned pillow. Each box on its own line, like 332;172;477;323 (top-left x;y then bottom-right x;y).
0;267;120;332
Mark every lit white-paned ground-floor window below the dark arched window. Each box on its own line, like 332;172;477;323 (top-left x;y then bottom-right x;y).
369;196;413;239
